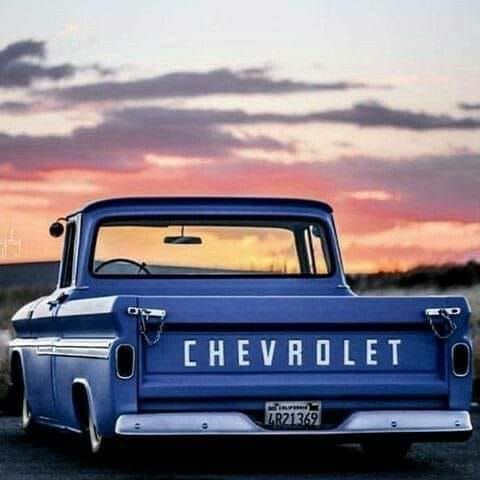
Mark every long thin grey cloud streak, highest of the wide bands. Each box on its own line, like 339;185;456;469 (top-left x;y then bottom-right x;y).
47;67;384;103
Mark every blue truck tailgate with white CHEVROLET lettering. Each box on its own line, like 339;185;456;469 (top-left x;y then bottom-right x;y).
133;296;469;406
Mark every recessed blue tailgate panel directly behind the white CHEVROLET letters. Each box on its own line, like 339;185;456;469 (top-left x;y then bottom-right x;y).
144;334;443;376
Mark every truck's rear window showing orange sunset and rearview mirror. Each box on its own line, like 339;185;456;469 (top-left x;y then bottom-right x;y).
92;220;330;277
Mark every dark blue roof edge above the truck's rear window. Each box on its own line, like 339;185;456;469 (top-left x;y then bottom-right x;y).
72;196;333;215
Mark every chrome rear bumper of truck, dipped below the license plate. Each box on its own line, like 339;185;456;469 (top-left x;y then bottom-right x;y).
115;410;472;437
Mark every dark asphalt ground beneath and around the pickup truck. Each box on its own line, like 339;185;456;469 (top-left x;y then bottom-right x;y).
0;413;480;480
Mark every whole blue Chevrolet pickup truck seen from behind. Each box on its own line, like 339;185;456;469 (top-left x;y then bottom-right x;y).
10;197;472;457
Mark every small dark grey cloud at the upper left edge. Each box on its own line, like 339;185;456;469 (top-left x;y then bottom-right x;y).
0;40;112;88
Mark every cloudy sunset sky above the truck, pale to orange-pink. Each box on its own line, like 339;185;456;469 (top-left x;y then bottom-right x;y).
0;0;480;272
